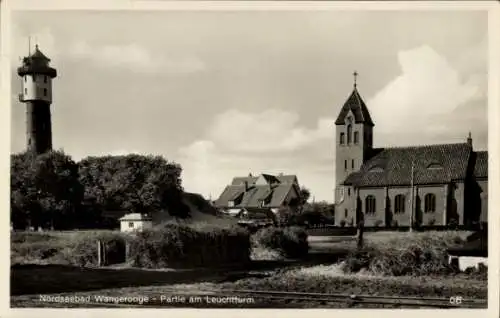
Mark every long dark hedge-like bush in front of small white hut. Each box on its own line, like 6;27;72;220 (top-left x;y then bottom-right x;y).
129;223;251;268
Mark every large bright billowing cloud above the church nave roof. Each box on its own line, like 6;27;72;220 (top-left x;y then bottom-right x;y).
368;46;486;145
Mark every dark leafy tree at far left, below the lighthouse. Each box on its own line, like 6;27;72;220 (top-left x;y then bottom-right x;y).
11;151;83;229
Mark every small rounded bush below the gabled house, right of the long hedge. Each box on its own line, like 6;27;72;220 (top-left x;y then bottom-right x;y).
252;227;309;258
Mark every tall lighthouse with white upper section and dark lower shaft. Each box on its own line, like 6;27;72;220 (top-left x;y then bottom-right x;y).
17;45;57;154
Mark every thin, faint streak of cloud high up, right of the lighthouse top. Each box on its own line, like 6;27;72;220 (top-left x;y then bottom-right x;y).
68;41;205;73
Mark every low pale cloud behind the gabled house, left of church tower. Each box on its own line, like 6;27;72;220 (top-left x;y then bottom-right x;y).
178;109;334;199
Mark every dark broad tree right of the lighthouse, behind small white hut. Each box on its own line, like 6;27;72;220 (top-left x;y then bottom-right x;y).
79;154;189;224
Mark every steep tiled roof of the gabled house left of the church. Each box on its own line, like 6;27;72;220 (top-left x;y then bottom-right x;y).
215;175;298;208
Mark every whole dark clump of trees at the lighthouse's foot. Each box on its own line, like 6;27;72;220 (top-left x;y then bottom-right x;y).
11;151;189;229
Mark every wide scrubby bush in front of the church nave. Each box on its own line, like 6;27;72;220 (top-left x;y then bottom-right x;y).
342;233;463;276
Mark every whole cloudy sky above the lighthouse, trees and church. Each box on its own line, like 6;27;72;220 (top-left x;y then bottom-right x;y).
10;10;488;202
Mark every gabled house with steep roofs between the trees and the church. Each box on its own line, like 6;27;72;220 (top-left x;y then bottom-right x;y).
215;174;301;215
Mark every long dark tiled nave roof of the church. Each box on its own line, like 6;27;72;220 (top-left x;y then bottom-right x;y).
344;143;472;187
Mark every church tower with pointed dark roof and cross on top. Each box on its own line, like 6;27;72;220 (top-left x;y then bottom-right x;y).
335;72;375;206
